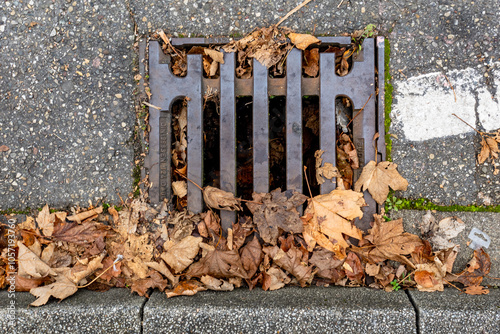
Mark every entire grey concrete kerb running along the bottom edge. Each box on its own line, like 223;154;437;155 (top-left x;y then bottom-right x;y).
0;287;500;334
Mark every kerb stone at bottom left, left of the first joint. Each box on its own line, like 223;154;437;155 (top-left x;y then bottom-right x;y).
0;288;146;334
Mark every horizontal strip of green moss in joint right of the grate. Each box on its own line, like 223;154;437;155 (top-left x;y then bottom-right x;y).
390;198;500;212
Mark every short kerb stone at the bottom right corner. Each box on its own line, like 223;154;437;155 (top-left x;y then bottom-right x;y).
408;288;500;334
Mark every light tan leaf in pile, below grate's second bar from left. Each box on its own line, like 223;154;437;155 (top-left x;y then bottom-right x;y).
161;235;203;273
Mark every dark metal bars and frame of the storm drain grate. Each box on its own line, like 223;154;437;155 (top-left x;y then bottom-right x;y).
146;37;385;229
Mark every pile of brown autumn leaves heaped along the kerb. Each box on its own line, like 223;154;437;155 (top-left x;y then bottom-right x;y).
0;154;490;306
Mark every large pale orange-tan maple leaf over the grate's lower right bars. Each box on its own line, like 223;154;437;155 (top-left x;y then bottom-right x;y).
302;189;365;260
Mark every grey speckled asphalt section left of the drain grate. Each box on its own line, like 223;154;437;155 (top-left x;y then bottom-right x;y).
0;0;135;209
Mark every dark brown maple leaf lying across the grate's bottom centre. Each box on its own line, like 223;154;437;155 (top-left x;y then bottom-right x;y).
247;188;307;245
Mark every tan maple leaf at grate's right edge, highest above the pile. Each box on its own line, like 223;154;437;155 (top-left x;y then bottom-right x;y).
354;161;408;205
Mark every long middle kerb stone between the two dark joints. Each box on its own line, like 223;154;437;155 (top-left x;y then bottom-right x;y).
143;287;416;334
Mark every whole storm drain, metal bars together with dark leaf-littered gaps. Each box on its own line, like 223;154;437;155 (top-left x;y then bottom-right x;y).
145;37;385;230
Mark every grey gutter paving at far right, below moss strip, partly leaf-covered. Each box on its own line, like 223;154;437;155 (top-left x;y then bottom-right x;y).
390;210;500;286
